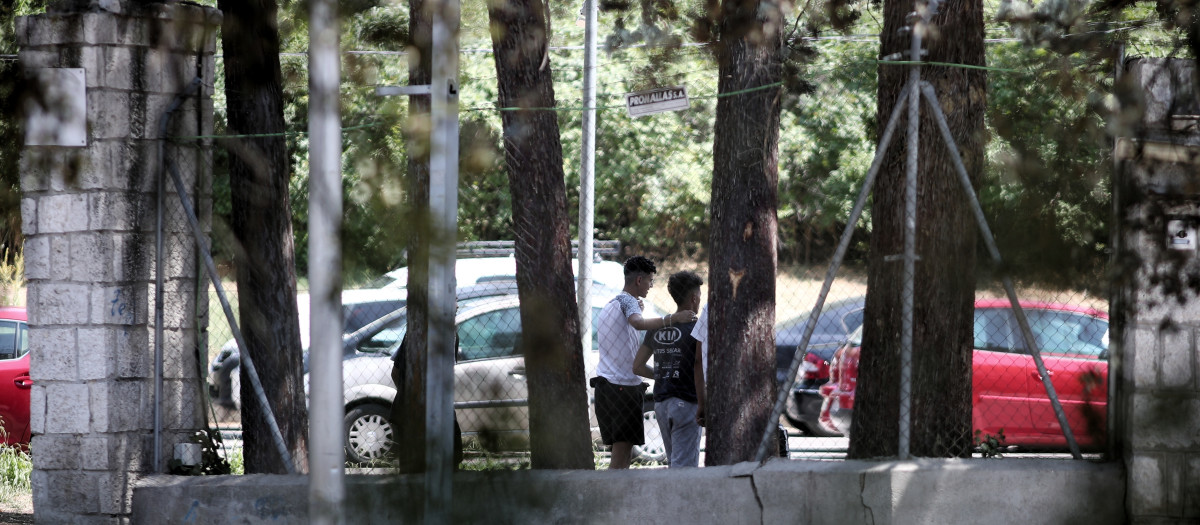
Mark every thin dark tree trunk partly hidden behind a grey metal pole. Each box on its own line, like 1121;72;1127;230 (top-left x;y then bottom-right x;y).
391;0;433;472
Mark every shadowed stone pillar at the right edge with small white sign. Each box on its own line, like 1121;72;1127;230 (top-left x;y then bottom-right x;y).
1110;59;1200;524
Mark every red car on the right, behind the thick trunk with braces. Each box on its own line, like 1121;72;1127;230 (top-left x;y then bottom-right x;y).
820;300;1109;448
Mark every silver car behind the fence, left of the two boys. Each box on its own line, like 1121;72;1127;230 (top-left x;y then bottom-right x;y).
328;290;666;463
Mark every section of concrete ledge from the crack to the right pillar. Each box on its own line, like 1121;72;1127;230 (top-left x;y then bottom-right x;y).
754;458;1126;525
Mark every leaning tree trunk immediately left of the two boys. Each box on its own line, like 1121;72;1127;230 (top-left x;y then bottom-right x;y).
488;0;594;469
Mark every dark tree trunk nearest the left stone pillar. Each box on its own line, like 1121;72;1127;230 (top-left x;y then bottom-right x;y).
218;0;308;473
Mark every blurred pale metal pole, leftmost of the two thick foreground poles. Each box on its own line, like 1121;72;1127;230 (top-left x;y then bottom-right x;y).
308;0;346;517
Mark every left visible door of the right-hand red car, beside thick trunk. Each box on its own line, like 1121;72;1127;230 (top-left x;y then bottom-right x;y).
971;307;1037;440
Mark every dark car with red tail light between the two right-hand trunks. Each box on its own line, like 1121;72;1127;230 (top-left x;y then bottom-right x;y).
775;296;865;436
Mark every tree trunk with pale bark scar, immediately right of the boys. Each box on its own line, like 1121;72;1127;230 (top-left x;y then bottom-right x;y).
704;0;784;465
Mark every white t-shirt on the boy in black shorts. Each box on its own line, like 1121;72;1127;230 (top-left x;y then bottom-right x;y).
596;291;642;386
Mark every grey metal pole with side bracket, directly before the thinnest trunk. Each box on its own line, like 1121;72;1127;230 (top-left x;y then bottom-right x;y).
425;0;460;525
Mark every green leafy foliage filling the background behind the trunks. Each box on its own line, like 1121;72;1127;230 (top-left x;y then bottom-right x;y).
0;0;1161;291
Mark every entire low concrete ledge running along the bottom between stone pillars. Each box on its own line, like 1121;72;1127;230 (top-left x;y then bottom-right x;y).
132;459;1126;525
